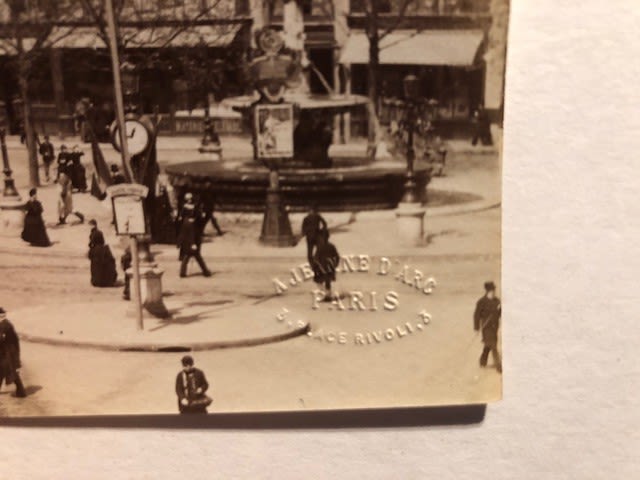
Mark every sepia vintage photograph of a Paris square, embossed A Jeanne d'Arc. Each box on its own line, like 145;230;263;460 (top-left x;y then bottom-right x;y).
0;0;509;417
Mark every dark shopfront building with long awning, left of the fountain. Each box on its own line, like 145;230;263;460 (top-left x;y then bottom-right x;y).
0;0;251;134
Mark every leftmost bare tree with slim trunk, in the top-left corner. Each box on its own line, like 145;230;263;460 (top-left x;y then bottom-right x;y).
0;0;79;187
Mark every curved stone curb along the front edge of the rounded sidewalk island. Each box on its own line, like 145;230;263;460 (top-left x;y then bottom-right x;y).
18;323;310;353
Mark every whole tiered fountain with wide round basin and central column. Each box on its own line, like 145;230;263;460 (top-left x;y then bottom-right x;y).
166;1;430;212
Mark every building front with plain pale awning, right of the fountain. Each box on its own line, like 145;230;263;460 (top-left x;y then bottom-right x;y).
340;0;508;136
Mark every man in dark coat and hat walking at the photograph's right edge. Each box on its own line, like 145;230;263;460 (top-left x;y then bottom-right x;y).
473;282;502;373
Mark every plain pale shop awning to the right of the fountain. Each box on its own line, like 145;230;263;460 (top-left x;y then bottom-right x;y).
340;30;484;67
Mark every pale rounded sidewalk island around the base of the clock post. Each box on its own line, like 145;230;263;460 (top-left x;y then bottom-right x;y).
13;299;309;352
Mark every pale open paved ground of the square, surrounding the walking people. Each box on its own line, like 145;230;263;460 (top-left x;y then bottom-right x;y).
0;137;501;416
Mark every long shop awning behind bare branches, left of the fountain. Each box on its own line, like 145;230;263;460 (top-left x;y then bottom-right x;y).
37;25;241;48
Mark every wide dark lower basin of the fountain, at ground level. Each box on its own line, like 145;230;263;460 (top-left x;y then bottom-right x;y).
165;159;430;212
